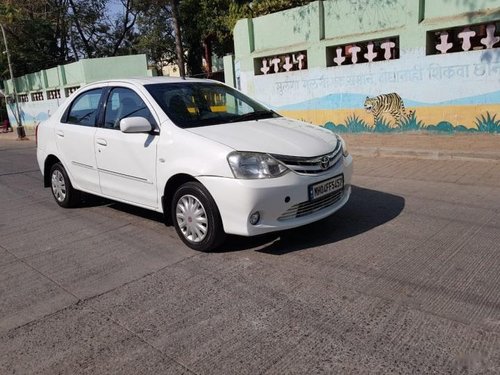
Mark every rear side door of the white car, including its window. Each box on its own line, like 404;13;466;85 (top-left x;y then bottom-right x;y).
55;87;104;193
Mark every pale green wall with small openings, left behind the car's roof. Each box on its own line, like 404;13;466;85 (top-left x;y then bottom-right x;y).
4;55;152;128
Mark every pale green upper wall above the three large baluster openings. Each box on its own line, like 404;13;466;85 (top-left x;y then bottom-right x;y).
229;0;500;71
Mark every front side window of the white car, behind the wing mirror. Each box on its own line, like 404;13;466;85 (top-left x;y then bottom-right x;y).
104;87;156;129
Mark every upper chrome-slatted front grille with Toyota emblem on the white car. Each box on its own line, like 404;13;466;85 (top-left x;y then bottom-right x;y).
272;141;342;175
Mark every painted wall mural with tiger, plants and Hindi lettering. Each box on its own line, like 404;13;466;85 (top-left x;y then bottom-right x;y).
240;48;500;133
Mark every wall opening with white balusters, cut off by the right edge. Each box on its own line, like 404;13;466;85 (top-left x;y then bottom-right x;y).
426;21;500;55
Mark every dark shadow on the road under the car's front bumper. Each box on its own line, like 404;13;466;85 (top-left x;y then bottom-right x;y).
219;186;405;255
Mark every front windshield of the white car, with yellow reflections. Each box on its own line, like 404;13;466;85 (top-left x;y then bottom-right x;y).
145;81;280;128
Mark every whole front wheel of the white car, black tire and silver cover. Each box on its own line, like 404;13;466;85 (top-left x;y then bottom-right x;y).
171;182;226;252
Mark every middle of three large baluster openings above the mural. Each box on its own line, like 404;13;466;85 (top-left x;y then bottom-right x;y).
326;36;399;66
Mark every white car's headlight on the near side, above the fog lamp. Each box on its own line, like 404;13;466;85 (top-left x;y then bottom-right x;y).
227;151;289;179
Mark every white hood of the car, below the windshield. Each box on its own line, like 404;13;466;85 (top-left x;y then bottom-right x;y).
187;117;338;157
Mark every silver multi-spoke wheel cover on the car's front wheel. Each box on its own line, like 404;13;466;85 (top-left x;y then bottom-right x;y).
175;195;208;243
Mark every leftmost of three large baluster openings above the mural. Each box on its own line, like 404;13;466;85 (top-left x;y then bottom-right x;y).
254;51;307;75
